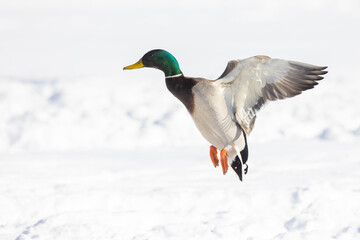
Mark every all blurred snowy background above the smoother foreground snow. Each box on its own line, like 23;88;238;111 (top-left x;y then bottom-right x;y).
0;0;360;151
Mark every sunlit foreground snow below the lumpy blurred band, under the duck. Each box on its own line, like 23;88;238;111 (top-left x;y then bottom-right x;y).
0;141;360;240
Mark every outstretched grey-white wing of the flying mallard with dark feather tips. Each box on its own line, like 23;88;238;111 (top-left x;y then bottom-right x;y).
216;56;327;134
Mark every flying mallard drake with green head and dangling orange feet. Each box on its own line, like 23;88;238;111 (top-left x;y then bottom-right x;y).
123;49;327;181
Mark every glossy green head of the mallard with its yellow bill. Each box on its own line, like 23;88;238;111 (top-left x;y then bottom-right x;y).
124;49;181;77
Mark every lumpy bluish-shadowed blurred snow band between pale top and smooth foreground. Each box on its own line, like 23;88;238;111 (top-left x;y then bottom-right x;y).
0;68;360;151
